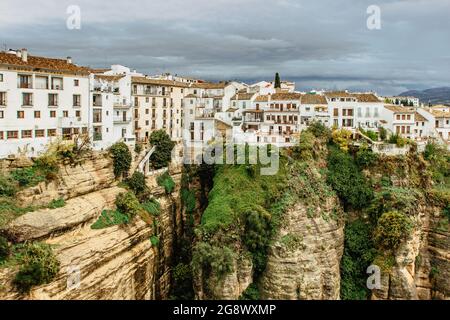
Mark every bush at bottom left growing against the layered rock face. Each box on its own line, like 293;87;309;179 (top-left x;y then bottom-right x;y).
13;243;60;293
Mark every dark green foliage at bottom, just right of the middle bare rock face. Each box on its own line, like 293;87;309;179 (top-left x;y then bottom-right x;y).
341;220;376;300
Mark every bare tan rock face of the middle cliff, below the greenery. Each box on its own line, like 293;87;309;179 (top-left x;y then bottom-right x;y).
261;198;344;300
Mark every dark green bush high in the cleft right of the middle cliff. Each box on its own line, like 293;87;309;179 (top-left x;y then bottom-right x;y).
327;147;373;209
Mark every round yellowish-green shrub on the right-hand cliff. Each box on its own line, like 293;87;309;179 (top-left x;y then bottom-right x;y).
374;211;413;250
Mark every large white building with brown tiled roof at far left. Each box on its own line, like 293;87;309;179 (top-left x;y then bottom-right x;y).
0;49;90;158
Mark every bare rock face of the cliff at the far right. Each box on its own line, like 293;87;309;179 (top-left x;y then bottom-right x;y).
372;204;450;300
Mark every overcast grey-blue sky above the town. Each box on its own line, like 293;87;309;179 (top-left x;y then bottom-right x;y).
0;0;450;94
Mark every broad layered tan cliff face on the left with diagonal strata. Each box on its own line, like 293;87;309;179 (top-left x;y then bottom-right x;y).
0;152;181;299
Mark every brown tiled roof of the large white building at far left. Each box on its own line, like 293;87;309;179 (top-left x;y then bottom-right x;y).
0;52;91;75
